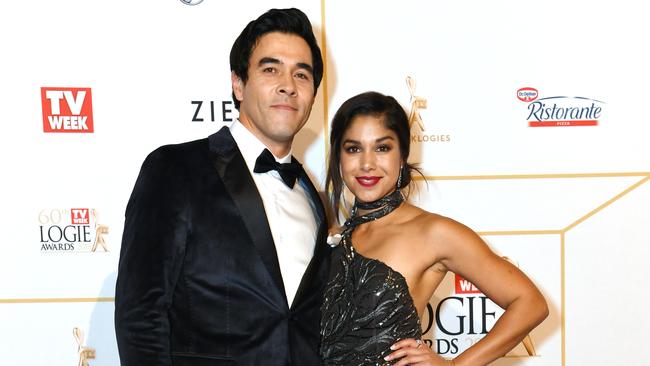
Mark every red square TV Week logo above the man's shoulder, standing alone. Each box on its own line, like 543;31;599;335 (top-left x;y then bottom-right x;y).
41;87;94;133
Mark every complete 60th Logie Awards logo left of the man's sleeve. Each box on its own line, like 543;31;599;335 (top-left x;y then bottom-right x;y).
38;208;108;253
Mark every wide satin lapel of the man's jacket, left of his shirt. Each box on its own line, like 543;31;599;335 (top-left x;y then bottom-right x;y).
209;127;288;306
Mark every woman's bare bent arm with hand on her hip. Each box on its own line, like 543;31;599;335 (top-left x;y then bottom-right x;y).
431;218;548;366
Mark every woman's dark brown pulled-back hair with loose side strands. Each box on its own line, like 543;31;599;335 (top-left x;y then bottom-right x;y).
325;92;418;218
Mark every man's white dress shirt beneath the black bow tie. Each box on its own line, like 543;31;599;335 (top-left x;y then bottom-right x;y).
230;120;317;306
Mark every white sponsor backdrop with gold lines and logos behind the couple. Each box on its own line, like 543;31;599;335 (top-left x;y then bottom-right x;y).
0;0;650;366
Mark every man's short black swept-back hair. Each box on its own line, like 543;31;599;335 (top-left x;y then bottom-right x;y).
230;8;323;110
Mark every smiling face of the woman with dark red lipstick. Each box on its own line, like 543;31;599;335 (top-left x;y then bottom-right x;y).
341;115;402;202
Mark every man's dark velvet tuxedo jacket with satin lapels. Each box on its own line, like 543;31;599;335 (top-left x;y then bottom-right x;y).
115;128;329;366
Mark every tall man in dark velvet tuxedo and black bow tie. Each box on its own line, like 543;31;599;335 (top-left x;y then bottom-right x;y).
115;9;329;366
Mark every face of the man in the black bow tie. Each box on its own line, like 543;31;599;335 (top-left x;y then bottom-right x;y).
232;32;314;156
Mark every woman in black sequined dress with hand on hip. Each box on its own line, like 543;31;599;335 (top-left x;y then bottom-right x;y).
321;92;548;366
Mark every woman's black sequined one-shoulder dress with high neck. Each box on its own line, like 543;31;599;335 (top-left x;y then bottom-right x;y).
321;190;422;366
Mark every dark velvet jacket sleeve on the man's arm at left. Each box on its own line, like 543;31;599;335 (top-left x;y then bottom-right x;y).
115;147;189;366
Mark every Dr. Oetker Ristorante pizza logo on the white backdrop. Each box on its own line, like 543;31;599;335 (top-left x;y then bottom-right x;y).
517;87;605;127
